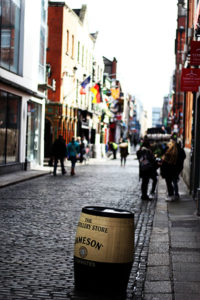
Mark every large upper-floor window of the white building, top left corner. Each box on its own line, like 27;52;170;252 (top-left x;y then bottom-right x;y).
0;0;21;74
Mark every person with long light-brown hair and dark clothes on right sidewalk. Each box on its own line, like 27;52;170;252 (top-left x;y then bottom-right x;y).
161;140;186;201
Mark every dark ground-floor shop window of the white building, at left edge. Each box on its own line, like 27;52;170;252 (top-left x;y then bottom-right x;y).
0;90;21;165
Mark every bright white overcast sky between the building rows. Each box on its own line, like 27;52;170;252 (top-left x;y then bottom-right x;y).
66;0;177;108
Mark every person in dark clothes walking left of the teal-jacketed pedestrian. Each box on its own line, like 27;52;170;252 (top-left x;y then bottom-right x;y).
52;135;67;176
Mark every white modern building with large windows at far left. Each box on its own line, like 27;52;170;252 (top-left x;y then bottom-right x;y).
0;0;47;174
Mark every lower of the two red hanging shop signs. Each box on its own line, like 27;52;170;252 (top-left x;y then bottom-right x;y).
181;69;200;92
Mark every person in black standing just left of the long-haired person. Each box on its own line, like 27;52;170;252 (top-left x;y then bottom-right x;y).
136;139;158;200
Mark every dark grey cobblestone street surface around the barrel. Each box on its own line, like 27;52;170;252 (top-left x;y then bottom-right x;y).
0;155;156;300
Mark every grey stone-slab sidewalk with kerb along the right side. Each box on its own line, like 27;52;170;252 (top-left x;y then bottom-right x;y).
144;178;200;300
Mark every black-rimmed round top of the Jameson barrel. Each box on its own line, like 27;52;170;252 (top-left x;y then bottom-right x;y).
82;206;134;218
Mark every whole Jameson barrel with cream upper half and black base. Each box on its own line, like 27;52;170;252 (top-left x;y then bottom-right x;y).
74;206;134;294
